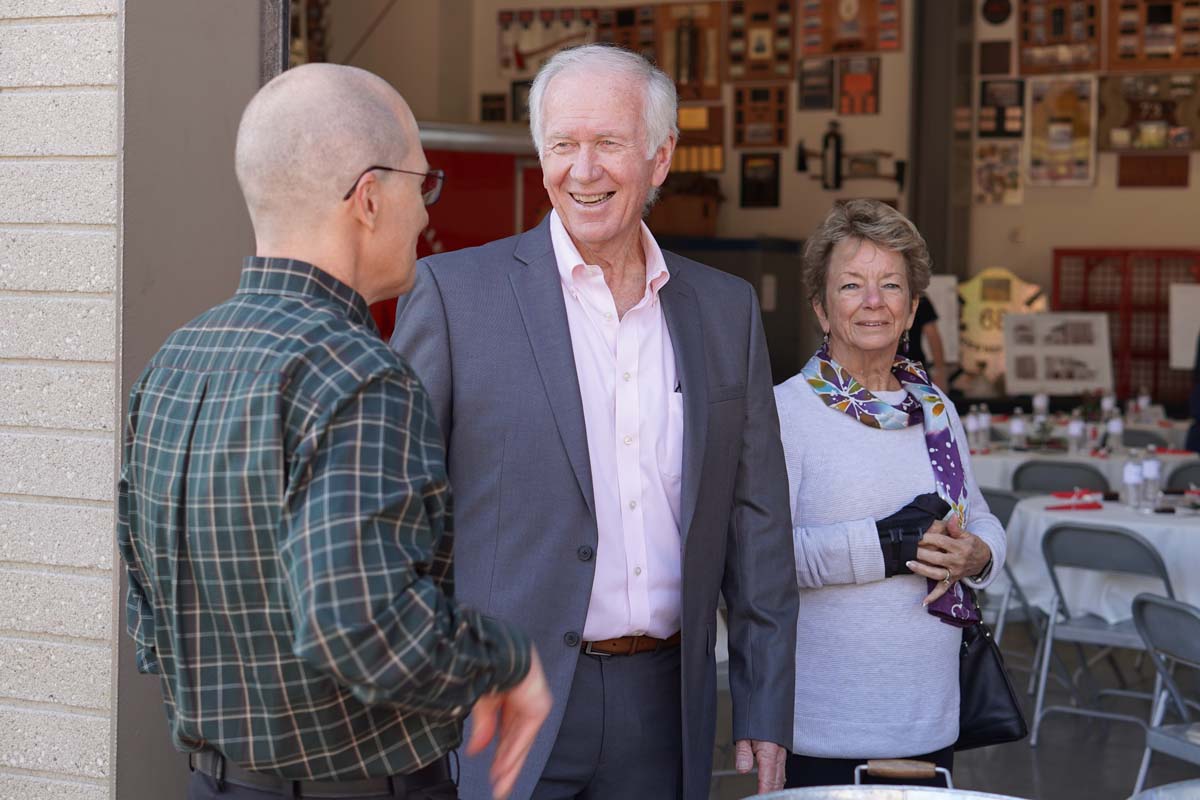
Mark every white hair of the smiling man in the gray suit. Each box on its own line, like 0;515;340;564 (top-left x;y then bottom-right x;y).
529;44;679;160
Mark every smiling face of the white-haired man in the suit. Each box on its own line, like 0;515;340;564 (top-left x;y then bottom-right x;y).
541;71;674;257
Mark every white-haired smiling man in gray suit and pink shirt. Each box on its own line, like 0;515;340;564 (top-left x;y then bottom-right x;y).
391;46;797;800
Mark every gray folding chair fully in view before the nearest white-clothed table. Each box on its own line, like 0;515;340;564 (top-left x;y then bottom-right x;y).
1030;523;1175;747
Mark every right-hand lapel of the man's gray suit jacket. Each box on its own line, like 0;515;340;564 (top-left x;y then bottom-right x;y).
659;252;708;541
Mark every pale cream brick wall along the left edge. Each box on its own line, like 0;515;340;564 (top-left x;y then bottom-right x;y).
0;0;120;800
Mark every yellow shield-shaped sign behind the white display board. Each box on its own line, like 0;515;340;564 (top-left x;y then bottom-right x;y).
959;266;1046;381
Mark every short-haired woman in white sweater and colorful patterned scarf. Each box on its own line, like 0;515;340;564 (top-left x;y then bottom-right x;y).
775;200;1004;787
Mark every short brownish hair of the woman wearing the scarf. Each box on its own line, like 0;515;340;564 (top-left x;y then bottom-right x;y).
800;199;932;308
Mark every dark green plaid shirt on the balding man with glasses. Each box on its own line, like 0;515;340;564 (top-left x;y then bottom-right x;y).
118;258;529;780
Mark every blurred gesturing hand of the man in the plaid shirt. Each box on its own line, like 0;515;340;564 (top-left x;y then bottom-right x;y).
467;650;551;800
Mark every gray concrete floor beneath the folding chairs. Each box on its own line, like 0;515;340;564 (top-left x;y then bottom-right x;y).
710;625;1200;800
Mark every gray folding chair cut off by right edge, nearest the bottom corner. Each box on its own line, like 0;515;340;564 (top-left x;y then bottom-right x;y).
1133;594;1200;794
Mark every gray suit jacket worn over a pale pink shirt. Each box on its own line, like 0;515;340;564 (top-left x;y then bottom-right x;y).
391;221;798;799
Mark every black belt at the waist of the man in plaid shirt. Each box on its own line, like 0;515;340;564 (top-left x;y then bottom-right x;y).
187;750;450;798
